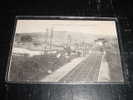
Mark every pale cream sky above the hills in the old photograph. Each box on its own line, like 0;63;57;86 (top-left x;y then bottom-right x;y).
16;20;117;37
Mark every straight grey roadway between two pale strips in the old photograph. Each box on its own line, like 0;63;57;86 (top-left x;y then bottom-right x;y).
59;52;103;83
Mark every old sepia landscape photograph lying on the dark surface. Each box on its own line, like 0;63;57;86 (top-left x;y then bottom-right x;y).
7;19;124;83
